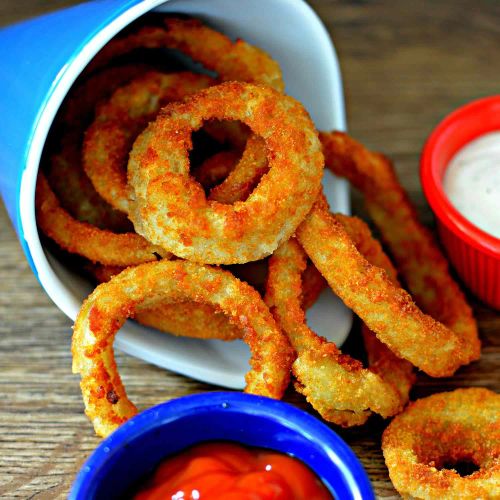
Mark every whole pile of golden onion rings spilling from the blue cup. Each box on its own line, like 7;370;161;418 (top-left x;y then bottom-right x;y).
36;18;492;497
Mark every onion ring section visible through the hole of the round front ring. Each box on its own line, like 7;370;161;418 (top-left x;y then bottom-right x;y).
208;135;269;204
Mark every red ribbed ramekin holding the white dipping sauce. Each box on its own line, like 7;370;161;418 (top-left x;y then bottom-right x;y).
420;95;500;310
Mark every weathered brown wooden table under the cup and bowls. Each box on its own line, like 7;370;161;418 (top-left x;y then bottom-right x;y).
0;0;500;498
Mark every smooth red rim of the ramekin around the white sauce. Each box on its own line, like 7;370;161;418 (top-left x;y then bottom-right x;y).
420;96;500;258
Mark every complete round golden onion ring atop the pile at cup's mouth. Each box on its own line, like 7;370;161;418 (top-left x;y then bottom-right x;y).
128;82;323;264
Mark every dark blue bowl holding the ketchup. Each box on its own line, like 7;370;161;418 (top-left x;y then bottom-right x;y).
69;392;375;500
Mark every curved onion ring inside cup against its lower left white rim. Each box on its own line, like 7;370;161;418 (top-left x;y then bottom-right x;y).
35;172;168;266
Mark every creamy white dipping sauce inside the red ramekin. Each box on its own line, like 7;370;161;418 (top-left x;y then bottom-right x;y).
443;131;500;238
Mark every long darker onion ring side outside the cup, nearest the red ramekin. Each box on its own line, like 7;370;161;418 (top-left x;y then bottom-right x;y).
320;132;481;361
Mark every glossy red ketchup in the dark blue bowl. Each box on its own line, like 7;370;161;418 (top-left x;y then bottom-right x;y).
134;443;333;500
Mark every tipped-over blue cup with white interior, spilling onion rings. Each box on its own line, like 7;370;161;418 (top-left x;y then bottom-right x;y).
0;0;352;388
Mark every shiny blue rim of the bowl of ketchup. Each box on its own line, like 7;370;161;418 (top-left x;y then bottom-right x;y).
68;391;375;500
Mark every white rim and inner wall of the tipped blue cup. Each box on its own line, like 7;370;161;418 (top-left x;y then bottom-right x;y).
21;0;352;389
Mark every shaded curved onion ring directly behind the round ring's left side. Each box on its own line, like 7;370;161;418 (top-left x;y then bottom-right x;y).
83;72;213;213
